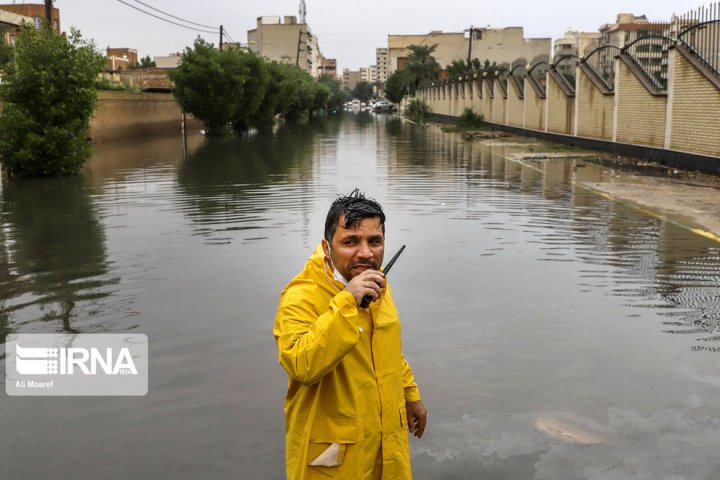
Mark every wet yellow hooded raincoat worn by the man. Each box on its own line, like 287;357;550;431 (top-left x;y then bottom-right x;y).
273;246;420;480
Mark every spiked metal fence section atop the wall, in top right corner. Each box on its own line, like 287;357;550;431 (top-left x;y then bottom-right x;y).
673;2;720;77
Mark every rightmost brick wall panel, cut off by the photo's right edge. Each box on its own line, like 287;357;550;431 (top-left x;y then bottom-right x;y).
670;51;720;157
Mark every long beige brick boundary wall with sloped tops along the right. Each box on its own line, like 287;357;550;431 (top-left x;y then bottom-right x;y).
416;50;720;174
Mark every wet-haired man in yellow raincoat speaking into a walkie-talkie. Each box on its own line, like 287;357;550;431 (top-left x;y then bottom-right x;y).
273;189;427;480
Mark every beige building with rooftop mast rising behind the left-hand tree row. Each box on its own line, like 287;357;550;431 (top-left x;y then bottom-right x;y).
247;16;322;77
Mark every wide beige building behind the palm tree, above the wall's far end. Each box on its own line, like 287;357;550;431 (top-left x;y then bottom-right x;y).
387;27;552;75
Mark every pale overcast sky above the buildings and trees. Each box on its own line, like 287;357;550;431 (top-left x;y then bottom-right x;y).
53;0;710;71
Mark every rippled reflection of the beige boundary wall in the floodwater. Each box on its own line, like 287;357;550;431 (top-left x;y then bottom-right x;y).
382;122;720;351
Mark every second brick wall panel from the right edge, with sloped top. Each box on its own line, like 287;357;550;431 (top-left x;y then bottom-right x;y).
615;61;667;147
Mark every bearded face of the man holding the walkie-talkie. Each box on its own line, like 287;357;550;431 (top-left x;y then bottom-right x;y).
322;216;385;280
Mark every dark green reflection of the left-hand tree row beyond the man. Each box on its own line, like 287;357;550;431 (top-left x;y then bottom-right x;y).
177;119;339;244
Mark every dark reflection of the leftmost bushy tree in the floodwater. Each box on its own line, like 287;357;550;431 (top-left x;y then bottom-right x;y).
0;178;114;338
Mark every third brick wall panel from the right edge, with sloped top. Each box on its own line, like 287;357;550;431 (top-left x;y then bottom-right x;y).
576;68;615;140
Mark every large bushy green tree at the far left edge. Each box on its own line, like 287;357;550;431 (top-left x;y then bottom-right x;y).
0;25;105;176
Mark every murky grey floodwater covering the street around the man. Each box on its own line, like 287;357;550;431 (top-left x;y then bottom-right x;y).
0;114;720;480
